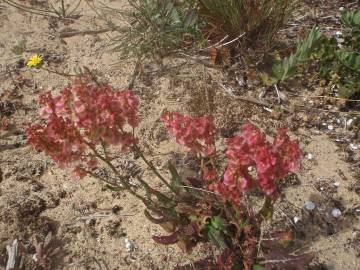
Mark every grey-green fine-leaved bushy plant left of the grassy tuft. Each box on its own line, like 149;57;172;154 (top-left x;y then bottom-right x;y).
104;0;201;57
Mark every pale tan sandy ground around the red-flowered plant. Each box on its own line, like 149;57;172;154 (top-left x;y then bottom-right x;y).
0;1;360;270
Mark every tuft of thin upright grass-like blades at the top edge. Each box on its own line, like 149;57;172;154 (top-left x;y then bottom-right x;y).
198;0;297;44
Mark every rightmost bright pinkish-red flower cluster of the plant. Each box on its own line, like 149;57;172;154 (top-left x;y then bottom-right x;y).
210;124;303;202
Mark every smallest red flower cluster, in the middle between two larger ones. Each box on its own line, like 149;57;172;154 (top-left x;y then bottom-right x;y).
161;112;216;156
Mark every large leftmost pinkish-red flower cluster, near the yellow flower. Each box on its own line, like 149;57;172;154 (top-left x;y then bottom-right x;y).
27;79;139;177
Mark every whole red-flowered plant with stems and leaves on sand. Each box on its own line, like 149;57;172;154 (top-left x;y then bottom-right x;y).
27;77;312;269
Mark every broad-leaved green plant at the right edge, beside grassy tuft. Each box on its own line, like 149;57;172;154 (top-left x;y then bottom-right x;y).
263;11;360;98
